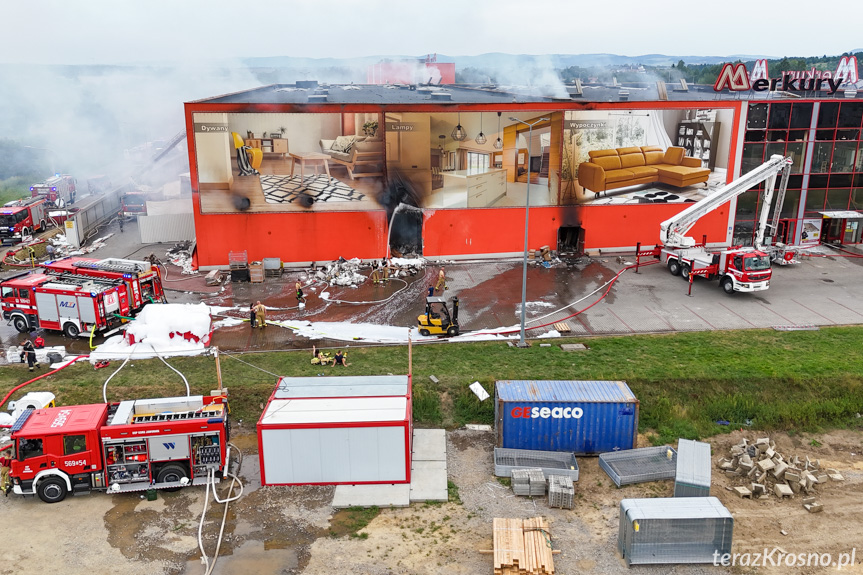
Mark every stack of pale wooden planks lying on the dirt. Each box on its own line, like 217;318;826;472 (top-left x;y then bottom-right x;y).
493;517;554;575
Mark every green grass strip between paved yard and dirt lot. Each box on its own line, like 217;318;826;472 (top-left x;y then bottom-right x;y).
6;327;863;444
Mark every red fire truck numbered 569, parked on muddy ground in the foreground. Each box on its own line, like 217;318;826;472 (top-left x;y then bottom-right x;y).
10;393;230;503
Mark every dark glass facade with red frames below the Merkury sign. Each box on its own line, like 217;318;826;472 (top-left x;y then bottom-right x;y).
734;101;863;244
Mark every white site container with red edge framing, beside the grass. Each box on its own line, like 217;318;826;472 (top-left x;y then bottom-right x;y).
257;376;413;485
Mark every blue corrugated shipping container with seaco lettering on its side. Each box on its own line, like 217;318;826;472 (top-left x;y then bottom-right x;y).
494;381;638;455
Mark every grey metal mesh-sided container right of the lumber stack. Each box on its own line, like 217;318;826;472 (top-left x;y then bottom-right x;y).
617;497;734;565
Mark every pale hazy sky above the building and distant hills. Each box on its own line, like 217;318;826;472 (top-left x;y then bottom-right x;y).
0;0;863;64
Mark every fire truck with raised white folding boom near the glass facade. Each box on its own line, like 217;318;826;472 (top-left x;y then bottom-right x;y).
638;155;793;294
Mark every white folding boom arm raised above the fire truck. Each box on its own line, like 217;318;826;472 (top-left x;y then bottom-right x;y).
659;155;791;248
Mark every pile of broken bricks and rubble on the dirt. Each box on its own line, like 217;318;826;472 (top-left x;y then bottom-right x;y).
718;437;844;513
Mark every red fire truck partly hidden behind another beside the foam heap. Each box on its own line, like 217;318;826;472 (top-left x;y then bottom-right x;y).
42;256;166;314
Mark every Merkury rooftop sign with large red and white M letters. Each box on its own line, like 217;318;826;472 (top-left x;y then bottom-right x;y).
713;56;859;95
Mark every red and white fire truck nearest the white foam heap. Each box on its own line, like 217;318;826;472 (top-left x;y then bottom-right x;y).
0;272;130;337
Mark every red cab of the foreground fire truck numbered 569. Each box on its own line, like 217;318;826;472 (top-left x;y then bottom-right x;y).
10;404;108;503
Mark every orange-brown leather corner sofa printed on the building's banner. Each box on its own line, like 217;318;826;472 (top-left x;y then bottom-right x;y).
578;146;710;197
